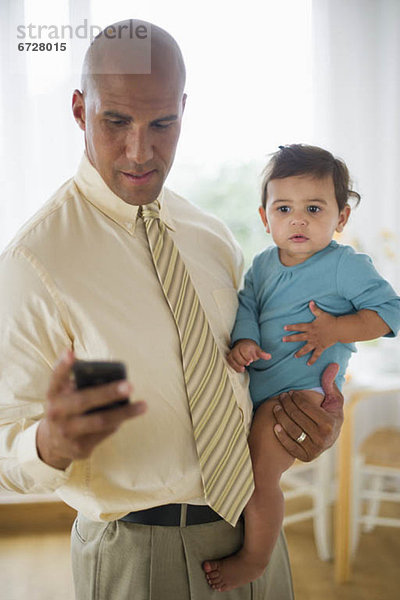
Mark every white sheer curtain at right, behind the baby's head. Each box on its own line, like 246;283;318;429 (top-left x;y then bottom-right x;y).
312;0;400;291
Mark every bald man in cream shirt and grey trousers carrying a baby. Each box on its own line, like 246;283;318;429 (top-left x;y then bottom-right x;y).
0;21;342;600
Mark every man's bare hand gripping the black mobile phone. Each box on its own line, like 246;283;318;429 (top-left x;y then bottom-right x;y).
36;350;147;470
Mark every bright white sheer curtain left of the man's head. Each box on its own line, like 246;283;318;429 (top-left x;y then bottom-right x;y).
0;0;90;249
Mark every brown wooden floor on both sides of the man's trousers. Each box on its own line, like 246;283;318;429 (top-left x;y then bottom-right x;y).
0;504;400;600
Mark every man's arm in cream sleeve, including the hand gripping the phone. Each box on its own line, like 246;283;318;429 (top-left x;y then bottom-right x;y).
0;248;146;493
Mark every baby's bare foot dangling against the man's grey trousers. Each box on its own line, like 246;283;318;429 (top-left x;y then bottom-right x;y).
203;552;267;592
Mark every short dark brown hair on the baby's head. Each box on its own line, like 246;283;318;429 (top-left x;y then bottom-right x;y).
261;144;361;211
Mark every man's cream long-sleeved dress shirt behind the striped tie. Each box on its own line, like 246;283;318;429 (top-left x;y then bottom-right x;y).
0;156;252;520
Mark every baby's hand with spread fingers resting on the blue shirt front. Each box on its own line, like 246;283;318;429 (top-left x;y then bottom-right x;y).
282;300;338;365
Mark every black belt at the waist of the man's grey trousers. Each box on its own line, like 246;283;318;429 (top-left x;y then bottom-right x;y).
119;504;222;527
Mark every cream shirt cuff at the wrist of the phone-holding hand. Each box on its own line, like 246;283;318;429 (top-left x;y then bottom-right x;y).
17;423;72;493
